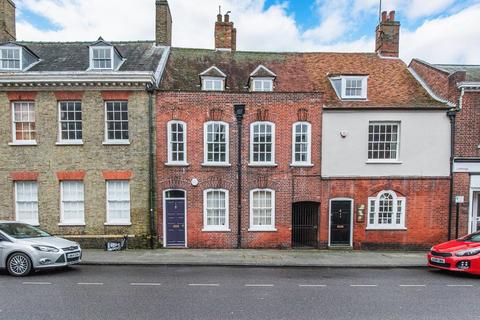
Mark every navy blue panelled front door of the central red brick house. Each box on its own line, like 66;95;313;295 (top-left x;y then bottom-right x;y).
165;199;185;246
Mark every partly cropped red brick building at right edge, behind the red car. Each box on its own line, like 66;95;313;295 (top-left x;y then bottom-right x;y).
410;59;480;238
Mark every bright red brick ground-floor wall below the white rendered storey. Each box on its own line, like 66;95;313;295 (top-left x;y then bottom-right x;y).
320;178;449;249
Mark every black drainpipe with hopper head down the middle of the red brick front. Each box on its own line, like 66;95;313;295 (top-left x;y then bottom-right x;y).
233;104;245;249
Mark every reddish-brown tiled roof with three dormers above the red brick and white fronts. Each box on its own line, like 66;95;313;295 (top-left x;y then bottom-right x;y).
160;48;445;108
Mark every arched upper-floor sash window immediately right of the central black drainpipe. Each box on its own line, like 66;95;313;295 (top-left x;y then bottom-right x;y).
250;122;275;164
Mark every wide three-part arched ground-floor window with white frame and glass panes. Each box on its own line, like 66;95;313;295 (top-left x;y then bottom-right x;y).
368;191;405;229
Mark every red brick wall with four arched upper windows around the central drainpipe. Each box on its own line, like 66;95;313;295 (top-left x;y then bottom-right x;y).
156;92;323;248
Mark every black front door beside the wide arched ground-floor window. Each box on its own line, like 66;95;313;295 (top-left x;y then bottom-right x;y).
330;200;352;246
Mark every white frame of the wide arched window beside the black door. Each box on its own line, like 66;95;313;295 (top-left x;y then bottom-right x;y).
367;190;407;230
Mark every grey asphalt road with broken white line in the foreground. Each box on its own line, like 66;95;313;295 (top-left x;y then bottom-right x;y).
0;266;480;320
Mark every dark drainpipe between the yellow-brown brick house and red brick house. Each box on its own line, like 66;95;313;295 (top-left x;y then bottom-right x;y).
147;85;157;249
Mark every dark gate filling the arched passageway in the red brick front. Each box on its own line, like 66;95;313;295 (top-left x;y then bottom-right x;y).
292;202;319;247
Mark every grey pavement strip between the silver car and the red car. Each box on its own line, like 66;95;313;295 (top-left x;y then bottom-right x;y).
82;249;426;268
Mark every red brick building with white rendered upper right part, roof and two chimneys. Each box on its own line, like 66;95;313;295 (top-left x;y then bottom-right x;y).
156;6;450;248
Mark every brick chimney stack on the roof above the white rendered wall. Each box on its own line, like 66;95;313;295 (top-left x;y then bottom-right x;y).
375;11;400;58
